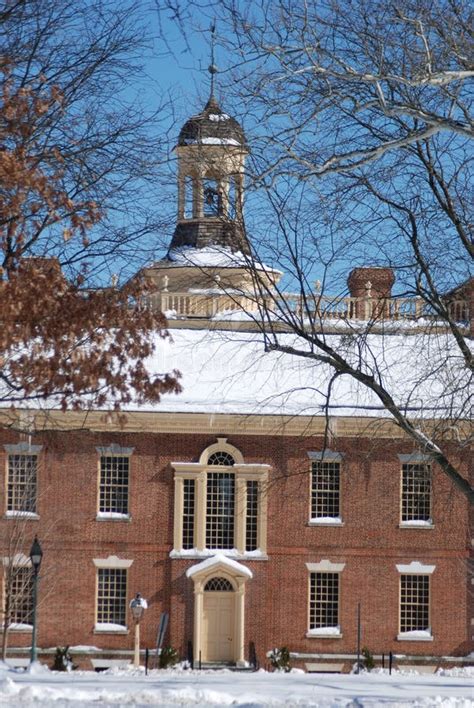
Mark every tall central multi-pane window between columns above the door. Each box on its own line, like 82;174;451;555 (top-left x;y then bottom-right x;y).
206;472;235;549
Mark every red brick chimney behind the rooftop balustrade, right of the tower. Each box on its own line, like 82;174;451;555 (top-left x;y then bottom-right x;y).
347;267;395;320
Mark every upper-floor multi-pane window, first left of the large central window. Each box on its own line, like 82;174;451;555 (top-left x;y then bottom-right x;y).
99;455;130;514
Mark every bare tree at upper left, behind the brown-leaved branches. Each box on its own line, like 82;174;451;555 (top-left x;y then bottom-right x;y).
0;0;177;283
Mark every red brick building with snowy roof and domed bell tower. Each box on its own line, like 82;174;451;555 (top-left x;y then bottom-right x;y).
0;92;474;669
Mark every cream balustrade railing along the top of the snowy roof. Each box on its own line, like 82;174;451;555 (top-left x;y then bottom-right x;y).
146;291;469;322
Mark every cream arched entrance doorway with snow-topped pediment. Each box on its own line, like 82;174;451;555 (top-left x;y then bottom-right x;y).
186;554;252;665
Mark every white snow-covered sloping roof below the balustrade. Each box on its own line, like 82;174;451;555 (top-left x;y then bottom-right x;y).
129;329;470;418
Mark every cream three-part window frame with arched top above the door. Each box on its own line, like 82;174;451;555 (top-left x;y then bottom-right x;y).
170;438;270;560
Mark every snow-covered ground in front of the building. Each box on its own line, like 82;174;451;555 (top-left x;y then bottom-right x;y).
0;667;474;708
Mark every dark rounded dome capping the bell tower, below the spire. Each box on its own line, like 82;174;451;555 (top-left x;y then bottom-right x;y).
178;96;247;149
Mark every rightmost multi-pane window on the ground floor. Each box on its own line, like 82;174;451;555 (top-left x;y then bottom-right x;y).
400;574;430;632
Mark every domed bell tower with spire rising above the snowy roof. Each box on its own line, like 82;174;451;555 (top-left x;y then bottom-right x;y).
142;33;281;320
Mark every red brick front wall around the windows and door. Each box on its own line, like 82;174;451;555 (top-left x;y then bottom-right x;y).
0;431;472;663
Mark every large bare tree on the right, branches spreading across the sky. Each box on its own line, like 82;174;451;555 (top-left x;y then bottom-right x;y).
160;0;474;502
